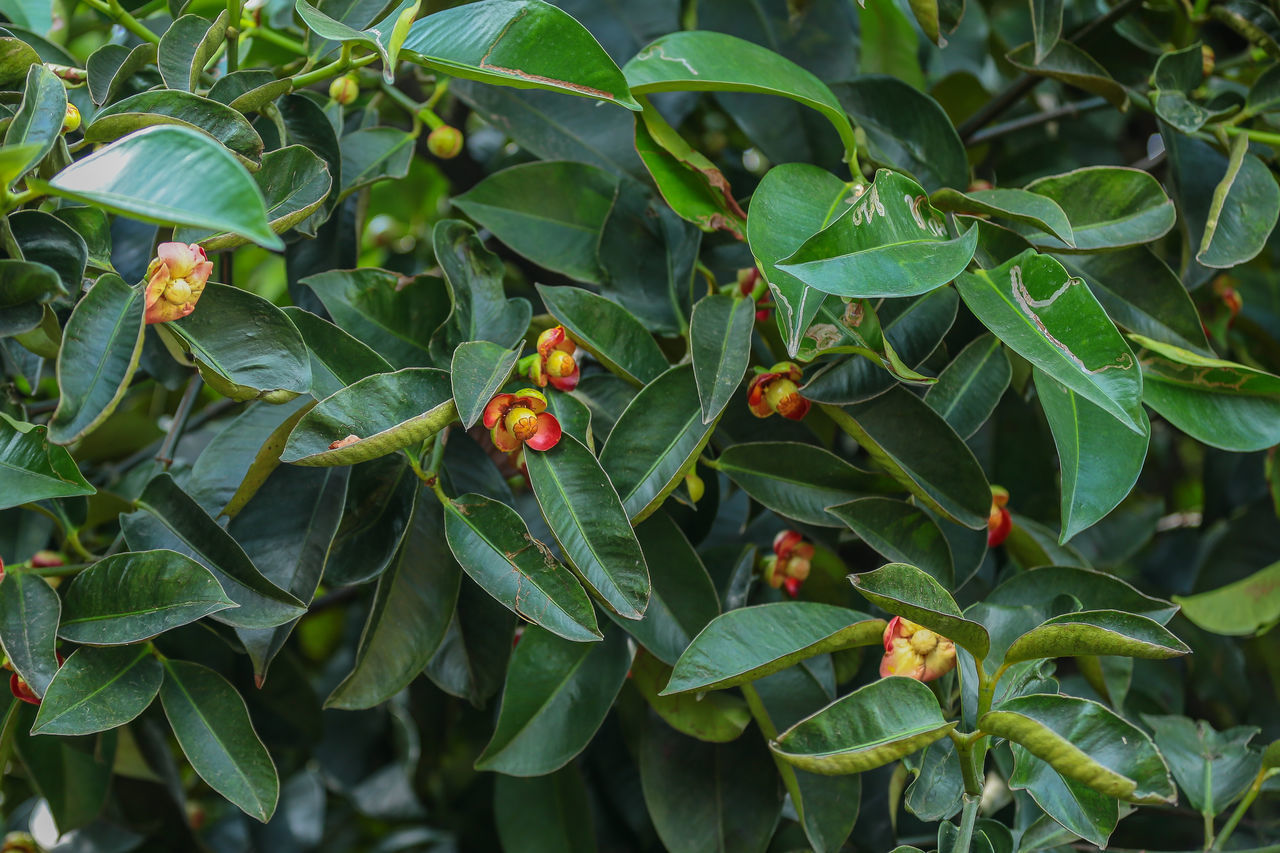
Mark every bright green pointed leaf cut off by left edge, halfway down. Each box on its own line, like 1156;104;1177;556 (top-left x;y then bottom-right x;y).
0;415;97;510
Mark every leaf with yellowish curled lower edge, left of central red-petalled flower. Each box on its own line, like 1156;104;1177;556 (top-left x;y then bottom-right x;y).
280;368;457;465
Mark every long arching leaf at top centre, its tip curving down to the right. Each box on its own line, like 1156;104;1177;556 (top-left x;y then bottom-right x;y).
622;31;858;159
